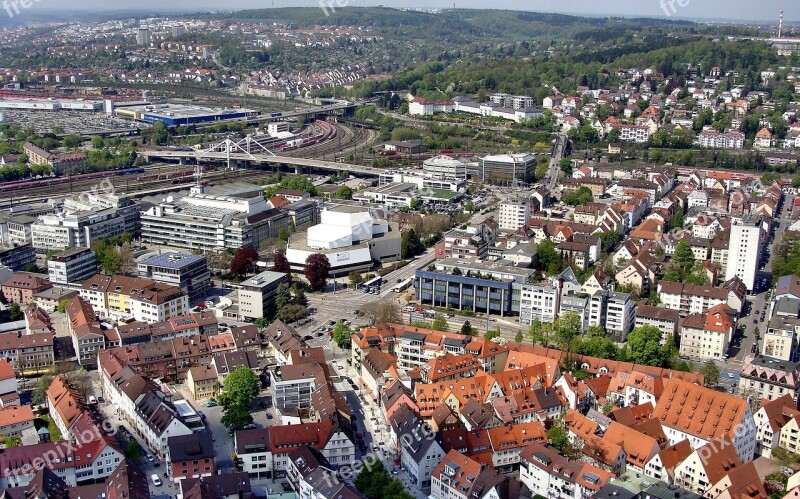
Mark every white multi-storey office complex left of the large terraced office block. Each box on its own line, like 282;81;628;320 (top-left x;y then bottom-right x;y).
31;193;140;253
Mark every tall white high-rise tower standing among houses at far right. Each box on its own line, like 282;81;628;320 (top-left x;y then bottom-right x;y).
725;216;766;291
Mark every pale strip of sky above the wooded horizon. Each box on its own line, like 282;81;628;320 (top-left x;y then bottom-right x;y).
25;0;800;23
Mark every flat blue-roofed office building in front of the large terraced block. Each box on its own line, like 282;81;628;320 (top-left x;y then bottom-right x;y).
139;252;211;303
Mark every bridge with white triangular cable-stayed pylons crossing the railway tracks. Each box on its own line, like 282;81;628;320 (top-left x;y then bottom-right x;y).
139;137;381;177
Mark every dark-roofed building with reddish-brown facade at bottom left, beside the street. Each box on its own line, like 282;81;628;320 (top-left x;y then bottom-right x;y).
164;433;217;484
